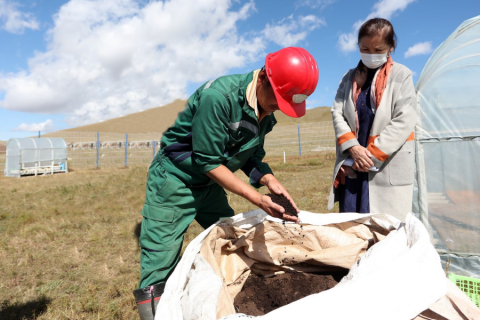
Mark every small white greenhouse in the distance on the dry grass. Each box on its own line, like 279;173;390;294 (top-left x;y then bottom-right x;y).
4;138;68;178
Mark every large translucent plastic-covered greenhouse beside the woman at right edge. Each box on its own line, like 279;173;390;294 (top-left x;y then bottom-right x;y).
413;16;480;277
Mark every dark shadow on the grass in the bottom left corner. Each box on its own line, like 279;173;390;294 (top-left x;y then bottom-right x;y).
0;296;52;320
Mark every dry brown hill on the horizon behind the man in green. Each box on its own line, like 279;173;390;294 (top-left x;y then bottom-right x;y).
59;100;332;133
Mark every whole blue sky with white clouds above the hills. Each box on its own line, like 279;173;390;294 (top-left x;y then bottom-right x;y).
0;0;480;140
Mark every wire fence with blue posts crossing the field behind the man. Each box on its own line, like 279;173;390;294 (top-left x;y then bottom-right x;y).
0;122;335;169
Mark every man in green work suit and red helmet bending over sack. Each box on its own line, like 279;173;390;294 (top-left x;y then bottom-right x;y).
134;47;318;320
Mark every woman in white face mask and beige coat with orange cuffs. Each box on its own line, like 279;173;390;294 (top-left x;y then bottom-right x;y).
328;18;416;221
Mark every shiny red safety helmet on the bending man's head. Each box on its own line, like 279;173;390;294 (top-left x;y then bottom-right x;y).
265;47;318;118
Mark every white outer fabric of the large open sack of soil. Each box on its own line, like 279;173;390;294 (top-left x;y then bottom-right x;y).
156;210;450;320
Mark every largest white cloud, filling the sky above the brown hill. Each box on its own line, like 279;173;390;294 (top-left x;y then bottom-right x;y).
0;0;265;125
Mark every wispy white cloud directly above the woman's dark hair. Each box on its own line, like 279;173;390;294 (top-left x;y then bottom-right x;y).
338;0;415;53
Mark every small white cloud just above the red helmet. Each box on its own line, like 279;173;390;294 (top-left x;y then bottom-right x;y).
263;15;326;47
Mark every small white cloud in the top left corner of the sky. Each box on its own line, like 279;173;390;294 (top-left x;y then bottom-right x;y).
0;0;39;34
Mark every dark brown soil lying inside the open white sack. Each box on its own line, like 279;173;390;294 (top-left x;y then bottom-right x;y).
234;272;346;316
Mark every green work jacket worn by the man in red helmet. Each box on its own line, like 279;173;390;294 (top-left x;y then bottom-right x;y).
159;72;277;188
